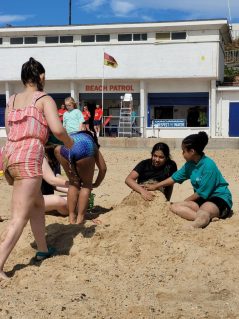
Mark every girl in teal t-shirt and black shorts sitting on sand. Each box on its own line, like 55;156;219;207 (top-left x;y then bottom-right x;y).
146;132;232;228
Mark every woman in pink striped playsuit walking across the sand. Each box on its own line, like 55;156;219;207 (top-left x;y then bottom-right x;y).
0;58;73;279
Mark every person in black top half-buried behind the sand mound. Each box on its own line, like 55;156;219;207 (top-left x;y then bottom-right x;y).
125;143;177;200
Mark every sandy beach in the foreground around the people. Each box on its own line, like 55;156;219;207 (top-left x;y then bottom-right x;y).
0;148;239;319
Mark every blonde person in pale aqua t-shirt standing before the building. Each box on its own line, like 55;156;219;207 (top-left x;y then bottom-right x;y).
63;96;85;134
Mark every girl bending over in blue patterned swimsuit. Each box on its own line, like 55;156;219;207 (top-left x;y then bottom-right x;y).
55;131;106;224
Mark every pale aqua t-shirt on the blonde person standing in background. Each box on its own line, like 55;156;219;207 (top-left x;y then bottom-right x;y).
63;109;85;134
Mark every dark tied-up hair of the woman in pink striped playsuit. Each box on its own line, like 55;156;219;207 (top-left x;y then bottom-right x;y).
21;58;45;91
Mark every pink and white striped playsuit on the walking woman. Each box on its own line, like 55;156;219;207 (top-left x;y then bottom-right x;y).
3;91;48;179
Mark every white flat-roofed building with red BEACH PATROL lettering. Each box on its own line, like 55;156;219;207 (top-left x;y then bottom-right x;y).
0;19;235;137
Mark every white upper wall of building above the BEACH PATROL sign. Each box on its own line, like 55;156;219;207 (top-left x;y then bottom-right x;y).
0;43;218;81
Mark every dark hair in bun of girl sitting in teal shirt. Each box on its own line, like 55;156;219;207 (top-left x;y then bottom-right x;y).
182;132;208;155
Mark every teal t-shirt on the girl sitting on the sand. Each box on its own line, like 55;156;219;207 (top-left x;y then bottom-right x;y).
171;155;232;208
